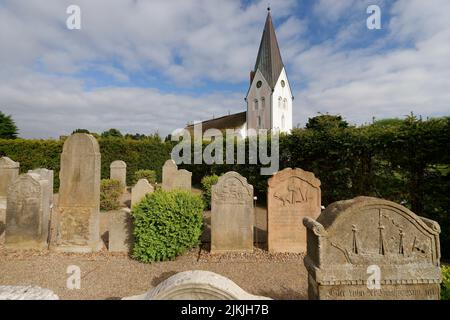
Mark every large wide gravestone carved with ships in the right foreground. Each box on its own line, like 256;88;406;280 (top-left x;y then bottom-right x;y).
303;197;441;300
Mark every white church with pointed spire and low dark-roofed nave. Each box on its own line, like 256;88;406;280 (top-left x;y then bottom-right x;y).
186;9;294;137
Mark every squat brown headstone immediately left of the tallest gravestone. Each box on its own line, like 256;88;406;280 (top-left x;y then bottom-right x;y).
5;173;50;249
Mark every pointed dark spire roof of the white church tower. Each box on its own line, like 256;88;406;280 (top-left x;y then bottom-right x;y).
255;11;284;89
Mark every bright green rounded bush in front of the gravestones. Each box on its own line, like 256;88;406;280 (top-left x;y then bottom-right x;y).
131;190;204;262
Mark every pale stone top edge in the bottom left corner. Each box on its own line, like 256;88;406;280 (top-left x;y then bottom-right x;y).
0;286;59;300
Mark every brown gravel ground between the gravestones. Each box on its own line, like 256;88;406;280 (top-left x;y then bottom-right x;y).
0;202;308;300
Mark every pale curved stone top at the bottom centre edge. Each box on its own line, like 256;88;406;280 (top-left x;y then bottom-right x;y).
123;270;270;300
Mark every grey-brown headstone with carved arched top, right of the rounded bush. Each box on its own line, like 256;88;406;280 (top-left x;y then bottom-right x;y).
211;172;255;253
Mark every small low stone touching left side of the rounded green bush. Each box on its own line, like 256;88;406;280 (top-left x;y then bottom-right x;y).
108;208;134;252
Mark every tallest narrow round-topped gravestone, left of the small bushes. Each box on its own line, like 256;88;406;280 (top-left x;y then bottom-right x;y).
56;133;102;252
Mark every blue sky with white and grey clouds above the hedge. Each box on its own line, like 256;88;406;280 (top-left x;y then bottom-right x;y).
0;0;450;138
